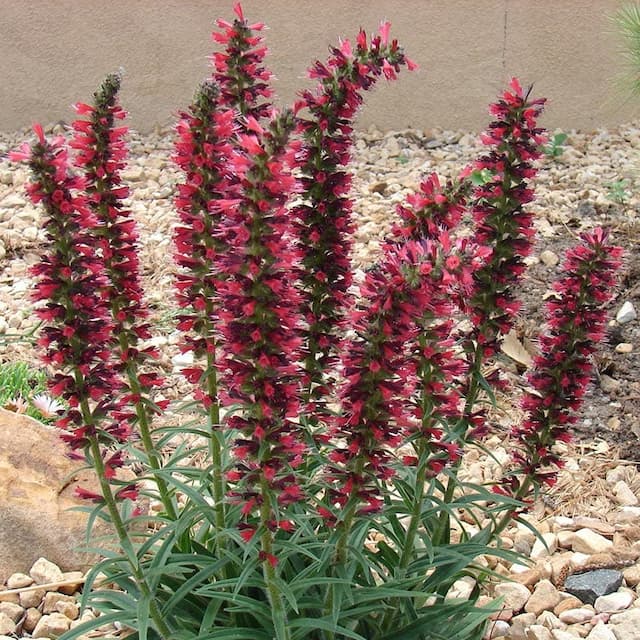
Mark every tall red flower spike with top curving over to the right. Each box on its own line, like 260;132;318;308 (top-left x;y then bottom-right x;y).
293;23;416;424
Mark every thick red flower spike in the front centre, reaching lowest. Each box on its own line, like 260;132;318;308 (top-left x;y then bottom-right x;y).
218;112;305;536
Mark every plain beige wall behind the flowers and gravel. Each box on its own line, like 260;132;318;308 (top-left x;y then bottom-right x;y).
0;0;640;131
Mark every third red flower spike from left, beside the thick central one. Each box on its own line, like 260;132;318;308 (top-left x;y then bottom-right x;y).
174;82;239;407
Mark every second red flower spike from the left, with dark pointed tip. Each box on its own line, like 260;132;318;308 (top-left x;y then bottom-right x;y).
69;75;162;421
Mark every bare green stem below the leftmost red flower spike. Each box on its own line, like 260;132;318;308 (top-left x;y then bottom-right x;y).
76;398;171;640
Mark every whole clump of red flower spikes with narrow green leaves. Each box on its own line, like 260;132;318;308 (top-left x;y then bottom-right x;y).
12;5;620;640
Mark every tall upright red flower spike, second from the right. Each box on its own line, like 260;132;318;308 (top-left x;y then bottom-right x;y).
469;78;545;356
